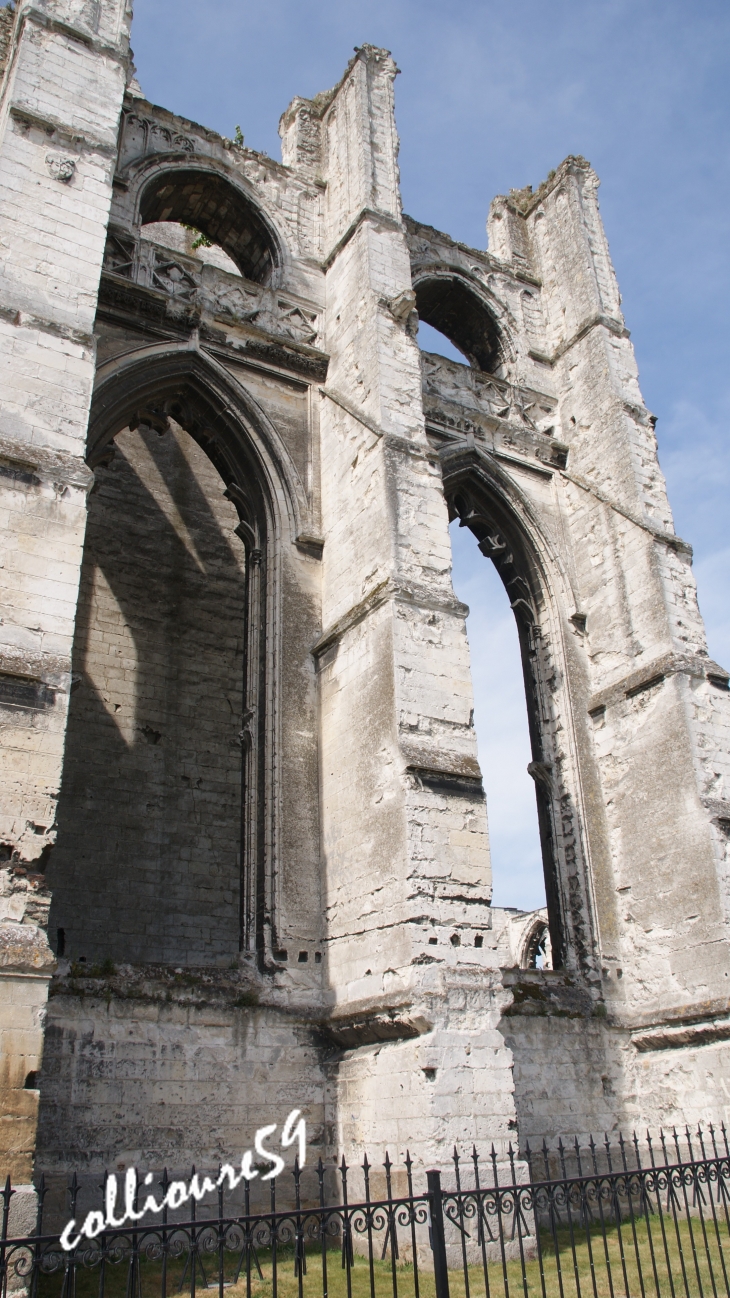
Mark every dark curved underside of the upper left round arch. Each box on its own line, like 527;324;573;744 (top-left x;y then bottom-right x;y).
139;167;278;284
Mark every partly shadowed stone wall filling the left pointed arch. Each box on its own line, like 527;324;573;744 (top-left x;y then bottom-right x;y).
48;427;245;964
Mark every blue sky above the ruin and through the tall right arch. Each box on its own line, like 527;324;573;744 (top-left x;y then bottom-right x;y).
132;0;730;906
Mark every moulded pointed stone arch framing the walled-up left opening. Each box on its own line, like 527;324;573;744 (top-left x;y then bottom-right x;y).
55;344;300;967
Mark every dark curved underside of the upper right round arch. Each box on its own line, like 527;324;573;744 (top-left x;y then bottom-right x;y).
414;275;501;374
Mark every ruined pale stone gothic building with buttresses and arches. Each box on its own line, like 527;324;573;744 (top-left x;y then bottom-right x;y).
0;0;730;1180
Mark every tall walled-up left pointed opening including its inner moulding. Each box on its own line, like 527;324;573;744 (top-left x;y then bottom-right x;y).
49;348;287;966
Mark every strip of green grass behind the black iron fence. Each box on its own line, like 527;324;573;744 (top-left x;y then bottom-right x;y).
31;1210;730;1298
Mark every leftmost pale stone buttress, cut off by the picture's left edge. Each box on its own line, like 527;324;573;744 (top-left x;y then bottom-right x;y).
0;0;131;1180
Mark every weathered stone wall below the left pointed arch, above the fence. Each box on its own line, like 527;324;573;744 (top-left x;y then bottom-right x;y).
36;966;326;1214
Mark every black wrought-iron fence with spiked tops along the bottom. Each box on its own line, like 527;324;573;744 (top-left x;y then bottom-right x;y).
0;1125;730;1298
